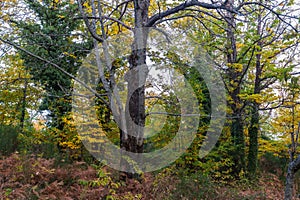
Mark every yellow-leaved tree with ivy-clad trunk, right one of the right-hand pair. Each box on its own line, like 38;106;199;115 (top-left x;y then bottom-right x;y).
244;1;298;178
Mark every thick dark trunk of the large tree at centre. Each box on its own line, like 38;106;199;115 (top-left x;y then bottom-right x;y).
121;0;150;177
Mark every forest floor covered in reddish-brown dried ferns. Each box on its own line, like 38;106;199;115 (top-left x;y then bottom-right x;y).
0;154;296;200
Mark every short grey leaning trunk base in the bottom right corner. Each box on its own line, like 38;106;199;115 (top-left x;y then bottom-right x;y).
284;156;300;200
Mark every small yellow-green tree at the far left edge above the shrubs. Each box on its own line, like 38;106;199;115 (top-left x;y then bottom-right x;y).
0;53;42;127
